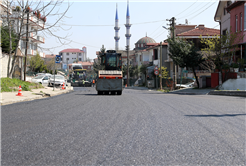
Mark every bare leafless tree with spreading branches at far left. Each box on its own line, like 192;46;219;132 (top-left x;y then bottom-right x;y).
0;0;70;77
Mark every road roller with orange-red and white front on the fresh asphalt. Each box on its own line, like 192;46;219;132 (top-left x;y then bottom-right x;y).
96;50;123;95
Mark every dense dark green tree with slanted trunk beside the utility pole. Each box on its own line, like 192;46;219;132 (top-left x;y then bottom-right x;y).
168;38;204;87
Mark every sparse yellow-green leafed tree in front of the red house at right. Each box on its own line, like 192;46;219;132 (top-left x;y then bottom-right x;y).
201;30;244;82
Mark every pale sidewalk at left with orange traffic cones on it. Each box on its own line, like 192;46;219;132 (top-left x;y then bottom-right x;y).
0;87;73;105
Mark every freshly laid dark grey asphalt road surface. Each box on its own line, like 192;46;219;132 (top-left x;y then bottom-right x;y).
0;87;246;166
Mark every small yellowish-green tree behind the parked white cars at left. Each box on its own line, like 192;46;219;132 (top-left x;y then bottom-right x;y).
28;54;47;72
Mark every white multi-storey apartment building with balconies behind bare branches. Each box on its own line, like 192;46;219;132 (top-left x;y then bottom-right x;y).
2;7;46;57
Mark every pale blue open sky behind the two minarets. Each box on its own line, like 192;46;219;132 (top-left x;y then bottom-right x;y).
42;0;219;59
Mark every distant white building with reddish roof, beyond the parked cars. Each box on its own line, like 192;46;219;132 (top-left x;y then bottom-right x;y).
59;47;87;66
